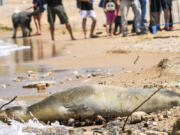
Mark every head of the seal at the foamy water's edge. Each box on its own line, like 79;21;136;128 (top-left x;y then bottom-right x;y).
0;106;26;122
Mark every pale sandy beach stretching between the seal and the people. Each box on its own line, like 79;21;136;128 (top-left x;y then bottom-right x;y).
0;0;180;133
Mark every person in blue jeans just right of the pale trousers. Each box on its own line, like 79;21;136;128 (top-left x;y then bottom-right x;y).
139;0;146;29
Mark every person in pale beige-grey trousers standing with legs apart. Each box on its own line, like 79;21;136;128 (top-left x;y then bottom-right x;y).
120;0;141;37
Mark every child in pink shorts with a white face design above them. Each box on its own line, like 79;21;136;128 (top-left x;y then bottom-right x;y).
103;0;117;36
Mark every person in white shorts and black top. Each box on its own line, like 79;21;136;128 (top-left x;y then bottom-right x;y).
80;0;97;39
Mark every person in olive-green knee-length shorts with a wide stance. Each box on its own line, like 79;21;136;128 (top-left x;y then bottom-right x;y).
47;0;75;43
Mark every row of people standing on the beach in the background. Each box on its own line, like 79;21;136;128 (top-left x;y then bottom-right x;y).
28;0;173;42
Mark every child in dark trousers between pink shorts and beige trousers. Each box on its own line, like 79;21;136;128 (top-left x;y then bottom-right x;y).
114;0;121;35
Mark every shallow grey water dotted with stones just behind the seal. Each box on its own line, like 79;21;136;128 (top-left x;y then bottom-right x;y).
0;65;122;98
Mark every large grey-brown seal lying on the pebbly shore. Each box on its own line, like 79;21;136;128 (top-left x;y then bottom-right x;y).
0;85;180;125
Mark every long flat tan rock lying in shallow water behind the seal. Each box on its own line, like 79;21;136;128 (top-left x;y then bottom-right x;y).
23;81;56;89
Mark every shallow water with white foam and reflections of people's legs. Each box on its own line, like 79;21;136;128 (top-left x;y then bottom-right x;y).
0;38;63;66
